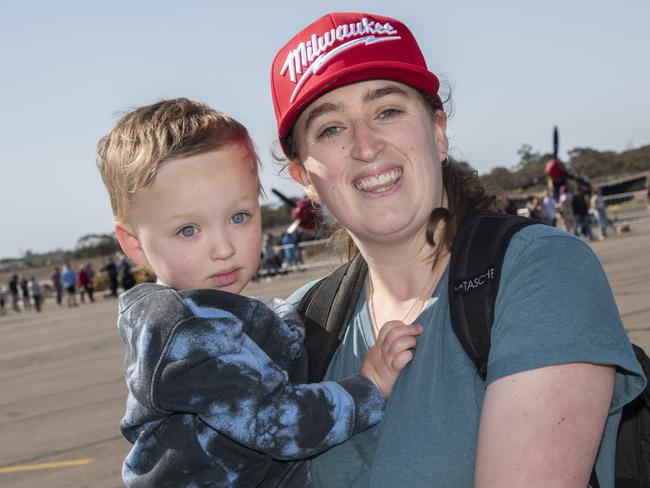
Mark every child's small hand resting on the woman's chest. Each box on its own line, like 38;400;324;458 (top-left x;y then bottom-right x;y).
361;320;422;398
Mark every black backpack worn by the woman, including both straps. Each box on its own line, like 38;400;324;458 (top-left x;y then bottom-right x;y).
298;212;650;488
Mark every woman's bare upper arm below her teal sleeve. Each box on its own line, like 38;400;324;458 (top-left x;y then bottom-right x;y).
474;363;615;488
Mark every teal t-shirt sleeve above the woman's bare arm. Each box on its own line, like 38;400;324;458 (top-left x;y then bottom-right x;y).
487;230;645;411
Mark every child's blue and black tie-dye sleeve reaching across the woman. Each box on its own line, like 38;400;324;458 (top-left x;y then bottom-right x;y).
152;312;384;459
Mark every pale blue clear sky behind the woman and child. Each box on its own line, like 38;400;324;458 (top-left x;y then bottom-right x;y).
0;0;650;257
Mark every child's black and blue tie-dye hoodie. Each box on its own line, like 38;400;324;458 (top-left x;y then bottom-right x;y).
118;284;384;488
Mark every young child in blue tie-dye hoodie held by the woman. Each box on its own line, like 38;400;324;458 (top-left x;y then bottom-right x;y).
97;99;421;488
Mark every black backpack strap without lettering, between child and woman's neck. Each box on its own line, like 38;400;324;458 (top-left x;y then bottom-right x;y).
297;254;368;382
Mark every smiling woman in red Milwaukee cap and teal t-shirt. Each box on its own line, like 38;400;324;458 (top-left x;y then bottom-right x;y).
271;13;644;488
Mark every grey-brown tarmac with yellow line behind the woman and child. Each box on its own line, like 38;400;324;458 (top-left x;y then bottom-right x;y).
0;219;650;488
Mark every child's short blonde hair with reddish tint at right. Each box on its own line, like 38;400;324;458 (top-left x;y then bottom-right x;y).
97;98;261;221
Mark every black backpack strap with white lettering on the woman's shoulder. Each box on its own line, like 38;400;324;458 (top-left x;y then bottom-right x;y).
448;212;536;380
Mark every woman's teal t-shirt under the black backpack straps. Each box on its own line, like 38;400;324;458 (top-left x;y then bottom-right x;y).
289;225;645;488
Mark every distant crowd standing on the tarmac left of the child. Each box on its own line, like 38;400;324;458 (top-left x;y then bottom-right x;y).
0;257;146;314
